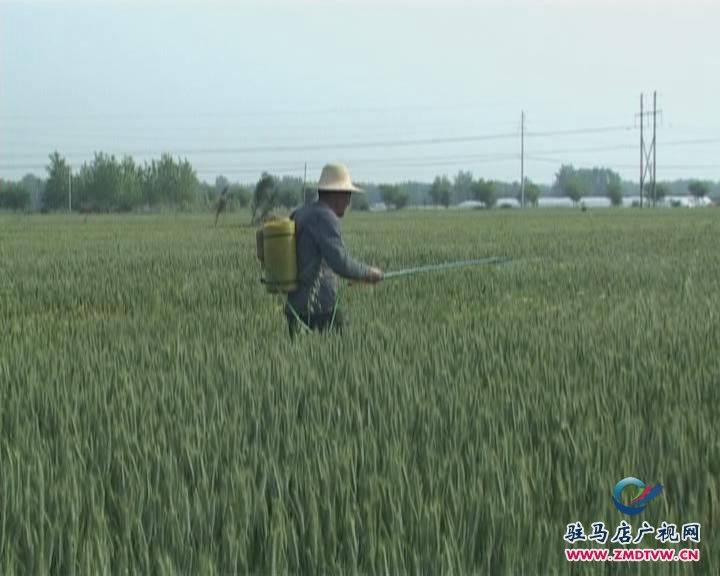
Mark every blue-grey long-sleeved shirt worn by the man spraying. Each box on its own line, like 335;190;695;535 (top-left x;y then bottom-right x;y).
288;201;368;317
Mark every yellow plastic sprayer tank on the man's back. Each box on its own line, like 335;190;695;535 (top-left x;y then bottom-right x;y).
262;218;298;293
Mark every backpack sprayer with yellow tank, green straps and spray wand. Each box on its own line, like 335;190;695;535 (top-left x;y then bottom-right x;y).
255;218;510;332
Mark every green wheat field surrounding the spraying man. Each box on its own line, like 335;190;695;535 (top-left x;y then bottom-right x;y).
0;209;720;575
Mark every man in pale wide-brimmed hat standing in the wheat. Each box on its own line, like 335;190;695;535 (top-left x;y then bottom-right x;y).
285;164;383;338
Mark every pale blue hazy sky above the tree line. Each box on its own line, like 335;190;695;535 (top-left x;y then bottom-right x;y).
0;0;720;183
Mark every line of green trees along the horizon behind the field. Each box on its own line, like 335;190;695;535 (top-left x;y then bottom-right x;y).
0;151;720;214
